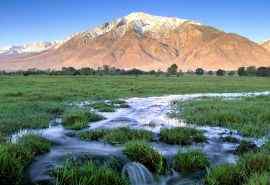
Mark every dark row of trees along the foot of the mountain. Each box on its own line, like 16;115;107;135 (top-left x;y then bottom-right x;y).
0;64;270;77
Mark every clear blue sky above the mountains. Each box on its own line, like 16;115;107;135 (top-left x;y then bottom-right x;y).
0;0;270;46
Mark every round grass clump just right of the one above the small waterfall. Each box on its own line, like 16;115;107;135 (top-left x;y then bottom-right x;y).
173;150;210;173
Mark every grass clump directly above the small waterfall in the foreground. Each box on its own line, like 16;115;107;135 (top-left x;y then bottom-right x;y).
123;141;166;174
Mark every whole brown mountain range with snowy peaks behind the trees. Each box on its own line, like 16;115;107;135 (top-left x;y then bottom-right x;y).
0;12;270;70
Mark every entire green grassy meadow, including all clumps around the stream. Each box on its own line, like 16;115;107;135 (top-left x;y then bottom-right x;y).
0;75;270;185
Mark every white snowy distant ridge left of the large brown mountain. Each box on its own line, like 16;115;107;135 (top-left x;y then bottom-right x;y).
0;41;60;55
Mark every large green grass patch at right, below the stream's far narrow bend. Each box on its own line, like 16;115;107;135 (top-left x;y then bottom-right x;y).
177;96;270;137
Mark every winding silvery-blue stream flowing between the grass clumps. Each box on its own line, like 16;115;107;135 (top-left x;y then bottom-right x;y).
11;92;270;185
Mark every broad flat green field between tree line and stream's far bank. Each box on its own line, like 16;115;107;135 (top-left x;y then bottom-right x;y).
0;75;270;135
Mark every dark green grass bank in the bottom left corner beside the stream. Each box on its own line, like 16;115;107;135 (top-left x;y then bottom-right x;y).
0;135;52;185
